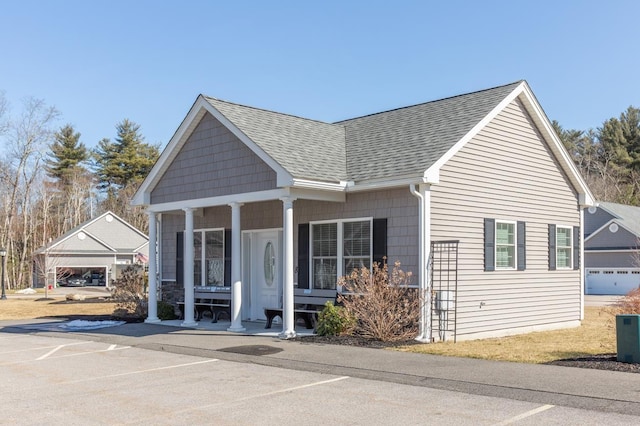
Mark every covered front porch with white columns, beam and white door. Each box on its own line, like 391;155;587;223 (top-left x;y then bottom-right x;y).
146;189;345;338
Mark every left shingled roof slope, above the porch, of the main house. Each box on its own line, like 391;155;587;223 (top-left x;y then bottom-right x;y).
206;98;347;182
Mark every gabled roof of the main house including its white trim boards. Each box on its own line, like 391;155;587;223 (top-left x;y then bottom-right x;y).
132;81;593;205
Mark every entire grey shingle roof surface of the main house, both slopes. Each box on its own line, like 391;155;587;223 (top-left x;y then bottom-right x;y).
205;81;521;182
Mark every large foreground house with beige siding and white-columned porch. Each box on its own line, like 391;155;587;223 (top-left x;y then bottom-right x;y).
133;81;593;341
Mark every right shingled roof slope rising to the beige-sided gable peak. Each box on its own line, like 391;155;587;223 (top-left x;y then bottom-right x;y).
337;82;520;181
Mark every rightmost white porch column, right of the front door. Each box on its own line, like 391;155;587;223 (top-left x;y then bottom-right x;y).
279;197;296;339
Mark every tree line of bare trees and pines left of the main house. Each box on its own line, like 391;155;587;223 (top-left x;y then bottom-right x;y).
0;92;160;288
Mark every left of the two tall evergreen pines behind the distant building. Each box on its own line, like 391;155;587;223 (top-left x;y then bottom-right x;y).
45;124;89;186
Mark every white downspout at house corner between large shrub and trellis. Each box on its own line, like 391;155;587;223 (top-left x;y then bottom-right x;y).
409;184;431;343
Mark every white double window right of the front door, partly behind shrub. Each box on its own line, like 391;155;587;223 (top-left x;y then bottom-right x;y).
311;219;373;289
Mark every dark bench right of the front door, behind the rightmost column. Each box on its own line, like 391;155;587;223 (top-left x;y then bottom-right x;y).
264;288;338;330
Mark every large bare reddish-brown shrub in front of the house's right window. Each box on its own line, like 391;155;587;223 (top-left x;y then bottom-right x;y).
338;262;423;342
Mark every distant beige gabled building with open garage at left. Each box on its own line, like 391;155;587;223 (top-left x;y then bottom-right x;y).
34;212;149;286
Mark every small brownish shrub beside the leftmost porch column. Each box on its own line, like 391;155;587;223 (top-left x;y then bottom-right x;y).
111;266;147;318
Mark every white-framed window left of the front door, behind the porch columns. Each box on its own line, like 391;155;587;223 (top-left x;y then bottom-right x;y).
193;229;224;287
